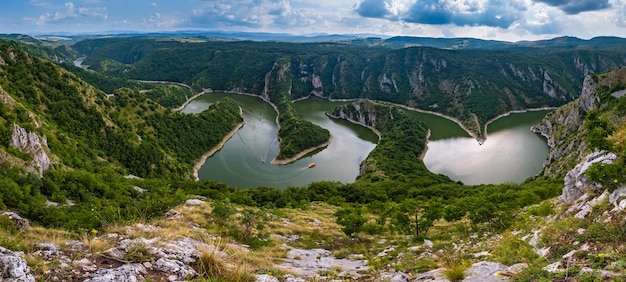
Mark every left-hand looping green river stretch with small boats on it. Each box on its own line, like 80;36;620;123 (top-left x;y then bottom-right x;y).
182;93;378;188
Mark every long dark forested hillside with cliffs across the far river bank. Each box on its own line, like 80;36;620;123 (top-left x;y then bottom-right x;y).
72;37;626;136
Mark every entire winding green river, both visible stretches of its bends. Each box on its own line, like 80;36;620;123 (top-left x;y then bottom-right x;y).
182;93;548;188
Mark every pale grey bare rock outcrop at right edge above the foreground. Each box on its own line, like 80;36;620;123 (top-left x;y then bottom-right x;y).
559;152;617;203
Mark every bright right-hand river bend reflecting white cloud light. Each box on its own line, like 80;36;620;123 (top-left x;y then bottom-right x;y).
424;111;548;185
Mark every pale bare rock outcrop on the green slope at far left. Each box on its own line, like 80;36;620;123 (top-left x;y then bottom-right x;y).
11;124;52;176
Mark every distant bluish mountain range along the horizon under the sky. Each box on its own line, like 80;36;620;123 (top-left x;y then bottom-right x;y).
0;30;626;49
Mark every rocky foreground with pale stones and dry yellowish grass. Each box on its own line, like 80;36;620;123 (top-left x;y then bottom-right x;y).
0;152;626;281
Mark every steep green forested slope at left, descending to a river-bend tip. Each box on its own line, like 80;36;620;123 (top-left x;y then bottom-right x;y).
0;39;241;177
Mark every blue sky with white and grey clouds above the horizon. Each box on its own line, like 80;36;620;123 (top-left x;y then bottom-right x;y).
0;0;626;41
